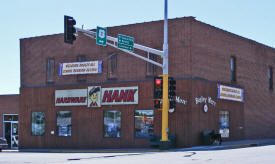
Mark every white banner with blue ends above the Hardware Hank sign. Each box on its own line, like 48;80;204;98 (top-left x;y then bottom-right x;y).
59;60;102;75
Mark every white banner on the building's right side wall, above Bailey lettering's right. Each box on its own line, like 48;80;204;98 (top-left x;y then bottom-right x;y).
217;84;244;102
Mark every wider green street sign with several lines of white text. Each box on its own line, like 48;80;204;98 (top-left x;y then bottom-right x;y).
117;34;134;51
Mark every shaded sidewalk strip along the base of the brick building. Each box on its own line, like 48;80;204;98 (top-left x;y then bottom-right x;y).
2;139;275;153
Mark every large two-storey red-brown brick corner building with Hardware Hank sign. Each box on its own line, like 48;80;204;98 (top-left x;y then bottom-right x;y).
19;17;275;148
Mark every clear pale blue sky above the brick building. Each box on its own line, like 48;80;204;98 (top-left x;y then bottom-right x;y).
0;0;275;95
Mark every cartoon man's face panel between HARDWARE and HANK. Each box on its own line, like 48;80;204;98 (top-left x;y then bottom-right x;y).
88;86;101;107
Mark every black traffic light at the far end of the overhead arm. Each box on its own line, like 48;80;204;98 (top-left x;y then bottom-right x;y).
64;15;76;44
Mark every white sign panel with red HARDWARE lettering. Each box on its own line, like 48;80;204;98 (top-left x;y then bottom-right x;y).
55;89;87;106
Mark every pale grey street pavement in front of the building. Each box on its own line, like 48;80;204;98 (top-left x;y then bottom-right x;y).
0;145;275;164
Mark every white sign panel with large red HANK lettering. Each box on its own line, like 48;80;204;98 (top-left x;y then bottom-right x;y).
101;86;138;105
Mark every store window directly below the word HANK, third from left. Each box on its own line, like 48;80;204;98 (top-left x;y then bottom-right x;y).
104;110;121;138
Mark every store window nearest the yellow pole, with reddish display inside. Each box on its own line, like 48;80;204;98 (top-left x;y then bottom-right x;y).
135;110;154;138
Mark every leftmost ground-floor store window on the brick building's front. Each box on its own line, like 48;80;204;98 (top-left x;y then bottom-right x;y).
31;112;45;136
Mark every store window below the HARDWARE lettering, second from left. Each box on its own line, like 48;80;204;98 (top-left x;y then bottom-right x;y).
56;111;72;136
